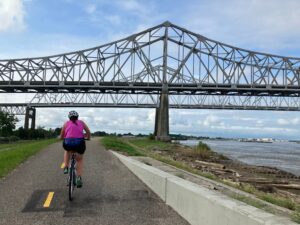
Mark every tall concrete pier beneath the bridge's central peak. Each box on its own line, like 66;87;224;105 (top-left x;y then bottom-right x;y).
154;91;171;141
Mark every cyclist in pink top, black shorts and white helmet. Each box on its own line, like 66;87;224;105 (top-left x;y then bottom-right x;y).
60;111;91;188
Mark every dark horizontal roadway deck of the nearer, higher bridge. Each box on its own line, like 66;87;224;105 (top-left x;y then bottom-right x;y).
0;81;300;97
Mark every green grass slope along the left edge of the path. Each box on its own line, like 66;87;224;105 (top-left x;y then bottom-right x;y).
0;139;57;178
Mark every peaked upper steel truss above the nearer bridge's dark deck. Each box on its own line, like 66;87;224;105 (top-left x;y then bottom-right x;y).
0;22;300;96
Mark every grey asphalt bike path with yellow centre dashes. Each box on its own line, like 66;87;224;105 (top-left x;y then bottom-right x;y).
0;140;188;225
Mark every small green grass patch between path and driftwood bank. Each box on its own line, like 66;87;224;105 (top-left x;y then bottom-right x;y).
101;137;143;156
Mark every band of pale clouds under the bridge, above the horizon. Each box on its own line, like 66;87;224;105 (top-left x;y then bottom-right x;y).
12;104;300;139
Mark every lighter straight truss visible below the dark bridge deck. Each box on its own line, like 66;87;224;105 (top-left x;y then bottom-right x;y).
0;93;300;115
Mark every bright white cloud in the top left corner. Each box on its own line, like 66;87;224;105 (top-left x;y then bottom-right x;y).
0;0;25;32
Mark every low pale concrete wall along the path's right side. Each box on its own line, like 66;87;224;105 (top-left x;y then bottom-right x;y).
113;152;296;225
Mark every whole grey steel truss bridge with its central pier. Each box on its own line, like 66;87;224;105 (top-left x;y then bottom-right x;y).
0;22;300;139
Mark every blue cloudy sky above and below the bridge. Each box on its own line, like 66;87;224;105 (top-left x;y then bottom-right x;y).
0;0;300;139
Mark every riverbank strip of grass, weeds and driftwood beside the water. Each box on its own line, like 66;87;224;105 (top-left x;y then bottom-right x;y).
101;136;300;223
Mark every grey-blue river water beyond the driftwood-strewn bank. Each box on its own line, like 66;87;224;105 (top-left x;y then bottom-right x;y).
180;140;300;176
